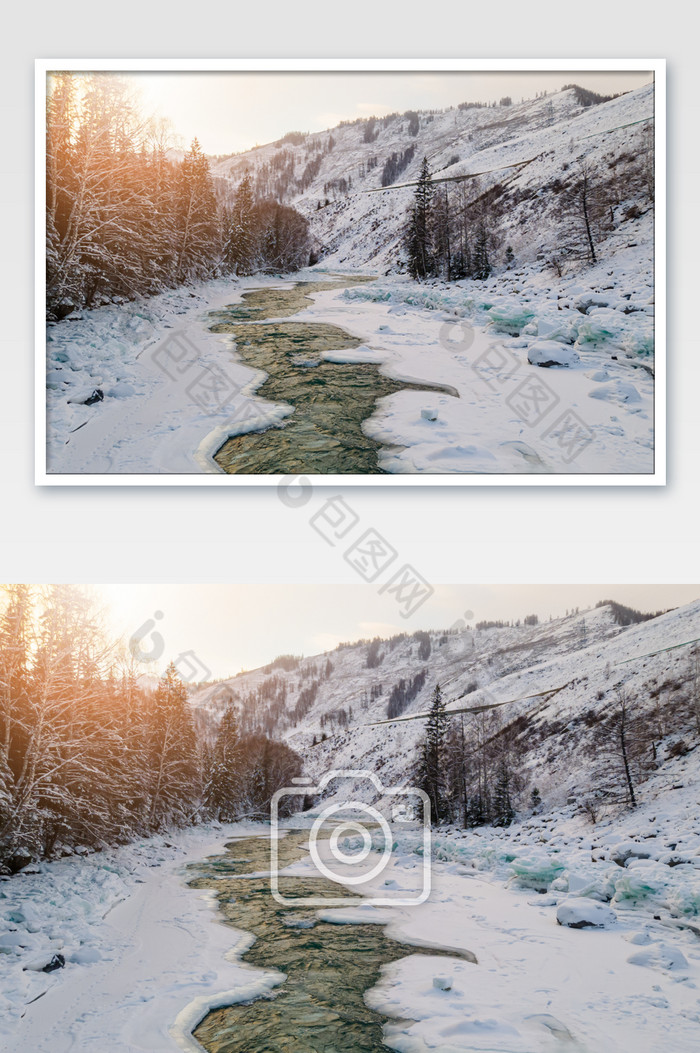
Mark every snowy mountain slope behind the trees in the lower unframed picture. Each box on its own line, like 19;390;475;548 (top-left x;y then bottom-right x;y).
192;601;700;806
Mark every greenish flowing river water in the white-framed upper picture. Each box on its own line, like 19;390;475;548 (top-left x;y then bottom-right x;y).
212;277;454;475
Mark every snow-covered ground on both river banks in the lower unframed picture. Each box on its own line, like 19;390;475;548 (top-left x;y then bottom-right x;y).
5;789;700;1053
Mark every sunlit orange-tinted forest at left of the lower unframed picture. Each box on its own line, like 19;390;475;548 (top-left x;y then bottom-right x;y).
0;584;301;872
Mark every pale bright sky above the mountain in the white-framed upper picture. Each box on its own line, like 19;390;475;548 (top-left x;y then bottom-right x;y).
117;71;652;154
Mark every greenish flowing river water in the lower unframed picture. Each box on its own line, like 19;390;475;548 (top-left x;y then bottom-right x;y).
191;831;476;1053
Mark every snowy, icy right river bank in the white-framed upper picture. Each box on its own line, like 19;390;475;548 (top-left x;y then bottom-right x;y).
295;254;654;475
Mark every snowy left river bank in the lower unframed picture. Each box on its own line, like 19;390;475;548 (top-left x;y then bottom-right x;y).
0;823;279;1053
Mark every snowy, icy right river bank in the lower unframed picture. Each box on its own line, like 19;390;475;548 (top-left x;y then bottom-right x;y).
277;790;700;1053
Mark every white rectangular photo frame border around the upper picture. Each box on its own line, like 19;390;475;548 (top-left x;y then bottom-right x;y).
35;58;666;486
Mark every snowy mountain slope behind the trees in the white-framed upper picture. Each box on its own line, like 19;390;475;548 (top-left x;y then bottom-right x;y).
212;84;654;274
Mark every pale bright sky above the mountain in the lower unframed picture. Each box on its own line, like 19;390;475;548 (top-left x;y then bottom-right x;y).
94;584;700;679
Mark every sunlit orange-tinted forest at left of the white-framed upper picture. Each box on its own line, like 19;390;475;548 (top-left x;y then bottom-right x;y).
46;73;309;319
